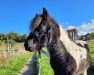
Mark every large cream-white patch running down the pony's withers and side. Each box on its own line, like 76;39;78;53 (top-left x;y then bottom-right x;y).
60;27;87;71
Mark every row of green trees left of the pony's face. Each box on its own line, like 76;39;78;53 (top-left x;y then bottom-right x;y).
0;32;28;42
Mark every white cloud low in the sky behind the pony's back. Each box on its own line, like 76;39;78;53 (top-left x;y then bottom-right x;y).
67;19;94;35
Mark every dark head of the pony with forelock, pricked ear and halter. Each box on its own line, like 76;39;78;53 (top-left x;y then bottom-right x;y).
24;8;60;51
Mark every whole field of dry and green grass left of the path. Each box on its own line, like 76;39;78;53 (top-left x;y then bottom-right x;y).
0;42;33;75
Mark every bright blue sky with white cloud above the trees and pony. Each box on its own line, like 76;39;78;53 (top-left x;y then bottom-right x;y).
0;0;94;35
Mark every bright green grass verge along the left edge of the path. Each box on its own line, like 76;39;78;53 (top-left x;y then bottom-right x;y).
0;53;32;75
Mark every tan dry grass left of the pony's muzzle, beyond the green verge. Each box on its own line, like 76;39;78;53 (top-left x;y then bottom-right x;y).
0;43;27;67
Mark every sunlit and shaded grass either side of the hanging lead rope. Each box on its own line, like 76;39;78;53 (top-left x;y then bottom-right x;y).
33;53;54;75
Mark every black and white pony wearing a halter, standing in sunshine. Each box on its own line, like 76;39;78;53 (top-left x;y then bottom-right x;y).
24;8;91;75
